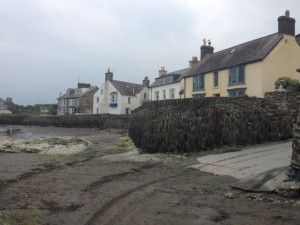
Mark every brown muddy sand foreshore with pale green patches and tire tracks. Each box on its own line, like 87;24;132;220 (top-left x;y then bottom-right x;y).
0;127;300;225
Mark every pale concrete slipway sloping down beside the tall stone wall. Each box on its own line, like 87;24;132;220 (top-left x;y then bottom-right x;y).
191;141;292;191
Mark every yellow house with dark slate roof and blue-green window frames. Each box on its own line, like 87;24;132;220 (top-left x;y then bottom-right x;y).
184;11;300;98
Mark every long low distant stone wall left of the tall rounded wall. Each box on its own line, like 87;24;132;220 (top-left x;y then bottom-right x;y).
0;114;130;129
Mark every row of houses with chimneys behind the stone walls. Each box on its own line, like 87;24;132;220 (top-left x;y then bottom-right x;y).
58;10;300;115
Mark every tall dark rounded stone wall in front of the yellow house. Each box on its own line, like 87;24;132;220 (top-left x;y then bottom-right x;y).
129;92;297;152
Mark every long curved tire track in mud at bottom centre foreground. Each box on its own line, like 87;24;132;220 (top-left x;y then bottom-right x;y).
84;174;184;225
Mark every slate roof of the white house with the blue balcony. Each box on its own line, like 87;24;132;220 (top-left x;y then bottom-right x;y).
111;80;145;96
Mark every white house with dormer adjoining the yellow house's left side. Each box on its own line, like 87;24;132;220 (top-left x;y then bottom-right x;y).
150;57;198;101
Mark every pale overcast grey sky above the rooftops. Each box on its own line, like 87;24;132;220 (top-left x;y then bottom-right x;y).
0;0;300;105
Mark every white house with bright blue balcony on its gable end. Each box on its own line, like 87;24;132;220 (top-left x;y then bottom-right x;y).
93;69;149;115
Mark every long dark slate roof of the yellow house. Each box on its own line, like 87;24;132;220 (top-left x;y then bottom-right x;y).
187;33;283;77
